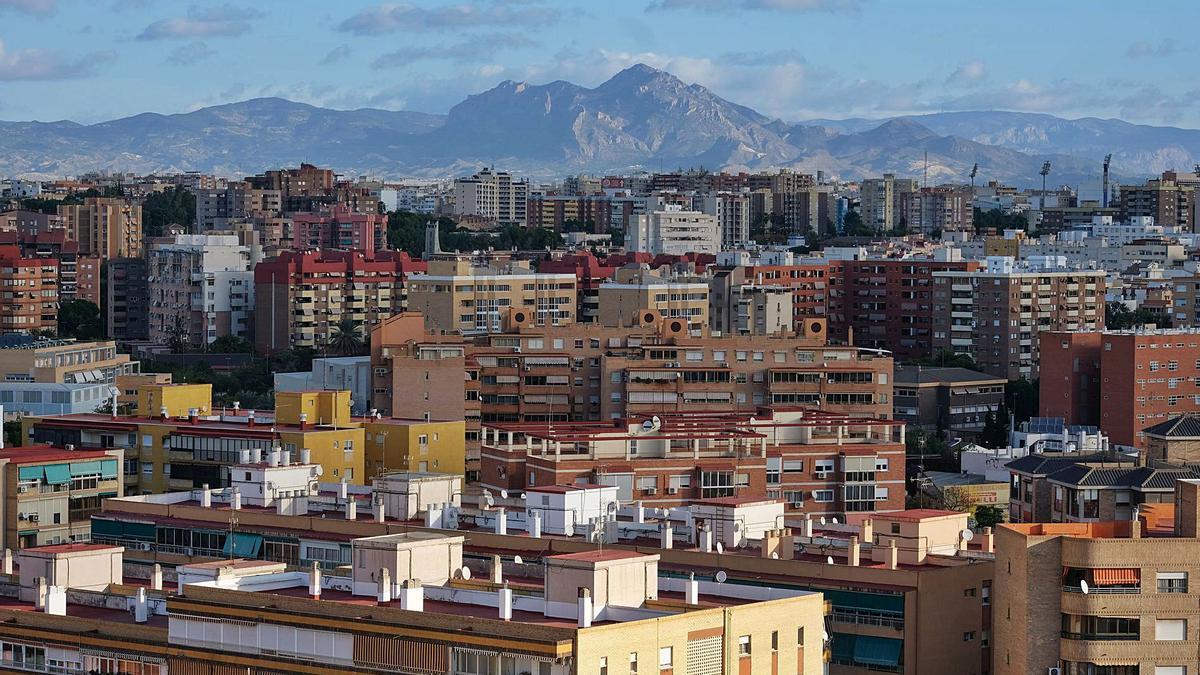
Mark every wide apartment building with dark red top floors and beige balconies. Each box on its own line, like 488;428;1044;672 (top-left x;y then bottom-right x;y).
253;251;425;353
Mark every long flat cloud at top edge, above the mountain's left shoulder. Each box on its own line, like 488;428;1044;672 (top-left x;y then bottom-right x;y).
337;0;563;35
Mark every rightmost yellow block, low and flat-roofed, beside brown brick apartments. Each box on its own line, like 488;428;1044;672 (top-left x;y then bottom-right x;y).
365;419;467;478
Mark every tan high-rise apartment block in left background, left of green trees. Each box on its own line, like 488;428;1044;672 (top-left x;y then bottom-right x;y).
59;197;142;261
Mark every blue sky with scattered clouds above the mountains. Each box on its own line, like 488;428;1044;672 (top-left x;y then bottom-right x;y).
0;0;1200;127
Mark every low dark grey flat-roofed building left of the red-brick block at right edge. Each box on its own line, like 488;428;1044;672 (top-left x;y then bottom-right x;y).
892;365;1008;437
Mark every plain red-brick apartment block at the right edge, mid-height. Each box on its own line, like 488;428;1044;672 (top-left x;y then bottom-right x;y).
1039;328;1200;448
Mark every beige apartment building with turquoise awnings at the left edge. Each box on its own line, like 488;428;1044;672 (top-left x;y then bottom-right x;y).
0;446;125;550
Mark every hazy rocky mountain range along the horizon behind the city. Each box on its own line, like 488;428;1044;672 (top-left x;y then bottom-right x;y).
0;65;1200;185
